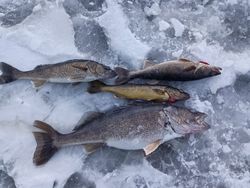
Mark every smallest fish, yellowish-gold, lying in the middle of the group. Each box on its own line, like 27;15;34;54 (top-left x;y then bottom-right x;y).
88;81;190;103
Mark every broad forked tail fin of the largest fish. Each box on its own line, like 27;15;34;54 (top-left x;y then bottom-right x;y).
33;121;60;166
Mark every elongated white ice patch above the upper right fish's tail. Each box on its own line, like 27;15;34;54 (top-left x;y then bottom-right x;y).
96;0;150;68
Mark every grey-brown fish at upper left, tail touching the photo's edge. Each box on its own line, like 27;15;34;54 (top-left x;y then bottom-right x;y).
0;59;116;88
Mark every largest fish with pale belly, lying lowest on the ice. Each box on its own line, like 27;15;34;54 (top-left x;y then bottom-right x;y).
33;104;210;166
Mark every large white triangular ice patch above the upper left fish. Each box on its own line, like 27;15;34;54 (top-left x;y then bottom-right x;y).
1;3;79;56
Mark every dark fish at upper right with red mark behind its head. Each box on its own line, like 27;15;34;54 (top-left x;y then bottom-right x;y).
115;58;222;85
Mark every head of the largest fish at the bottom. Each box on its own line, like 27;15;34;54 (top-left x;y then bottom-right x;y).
164;106;210;135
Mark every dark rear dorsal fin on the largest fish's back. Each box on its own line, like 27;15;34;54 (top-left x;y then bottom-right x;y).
73;111;103;131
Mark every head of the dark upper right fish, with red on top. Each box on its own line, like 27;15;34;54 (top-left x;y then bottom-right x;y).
195;61;222;77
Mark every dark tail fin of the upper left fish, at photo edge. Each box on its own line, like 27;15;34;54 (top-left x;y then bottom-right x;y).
0;62;20;84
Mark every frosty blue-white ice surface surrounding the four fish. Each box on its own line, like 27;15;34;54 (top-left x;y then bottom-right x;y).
0;0;250;188
